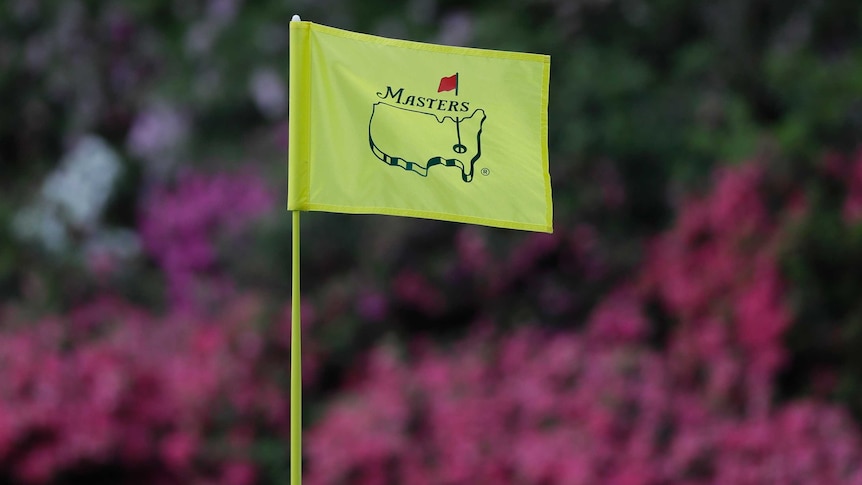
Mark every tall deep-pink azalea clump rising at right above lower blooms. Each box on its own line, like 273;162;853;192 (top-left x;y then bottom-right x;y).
643;164;791;413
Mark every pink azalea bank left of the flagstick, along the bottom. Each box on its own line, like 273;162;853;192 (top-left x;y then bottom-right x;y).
0;298;314;485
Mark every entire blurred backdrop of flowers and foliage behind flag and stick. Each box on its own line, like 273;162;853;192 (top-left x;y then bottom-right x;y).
0;0;862;485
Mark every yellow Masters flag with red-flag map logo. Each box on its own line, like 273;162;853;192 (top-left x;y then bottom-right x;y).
288;21;553;232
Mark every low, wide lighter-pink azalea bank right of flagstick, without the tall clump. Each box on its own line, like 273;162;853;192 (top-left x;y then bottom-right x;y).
305;318;862;485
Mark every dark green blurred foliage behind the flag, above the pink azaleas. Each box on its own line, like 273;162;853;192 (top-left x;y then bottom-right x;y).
0;0;862;476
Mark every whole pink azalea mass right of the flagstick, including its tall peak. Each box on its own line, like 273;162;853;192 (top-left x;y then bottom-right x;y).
305;164;862;485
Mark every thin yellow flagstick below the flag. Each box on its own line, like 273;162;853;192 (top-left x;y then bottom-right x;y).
290;211;302;485
